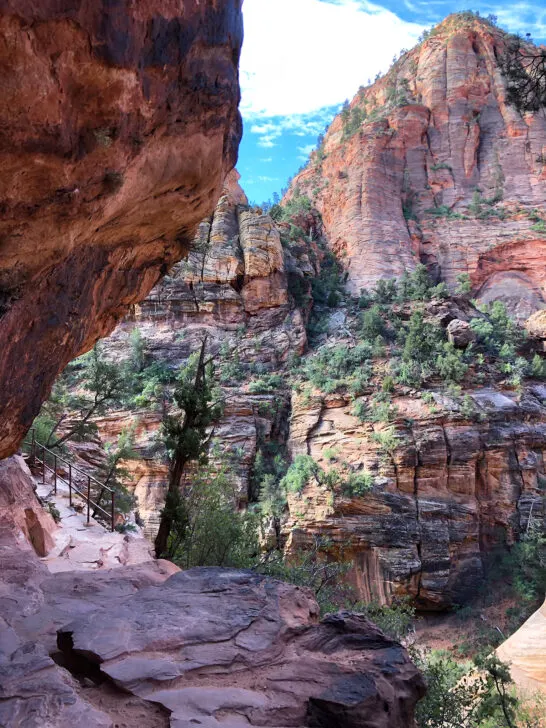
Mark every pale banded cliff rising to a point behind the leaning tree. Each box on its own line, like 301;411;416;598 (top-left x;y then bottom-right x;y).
97;172;307;538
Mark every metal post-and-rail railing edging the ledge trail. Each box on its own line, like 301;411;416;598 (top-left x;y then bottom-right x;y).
24;429;116;531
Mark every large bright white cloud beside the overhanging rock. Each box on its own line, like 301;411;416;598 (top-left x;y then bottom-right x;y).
241;0;423;118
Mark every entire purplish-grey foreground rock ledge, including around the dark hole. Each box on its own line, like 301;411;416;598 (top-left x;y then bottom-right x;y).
0;463;424;728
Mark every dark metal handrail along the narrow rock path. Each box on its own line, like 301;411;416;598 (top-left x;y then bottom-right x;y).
23;428;116;531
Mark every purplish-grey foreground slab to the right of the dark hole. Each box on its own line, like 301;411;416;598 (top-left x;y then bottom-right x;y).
59;569;422;728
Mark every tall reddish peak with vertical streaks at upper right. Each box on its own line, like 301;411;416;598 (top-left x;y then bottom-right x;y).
289;16;546;318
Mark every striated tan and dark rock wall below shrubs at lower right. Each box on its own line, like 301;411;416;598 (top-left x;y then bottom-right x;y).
284;385;546;609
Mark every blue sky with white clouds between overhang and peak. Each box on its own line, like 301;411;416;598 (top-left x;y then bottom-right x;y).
237;0;546;204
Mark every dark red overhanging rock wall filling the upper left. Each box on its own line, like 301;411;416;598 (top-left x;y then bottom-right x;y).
0;0;242;457
